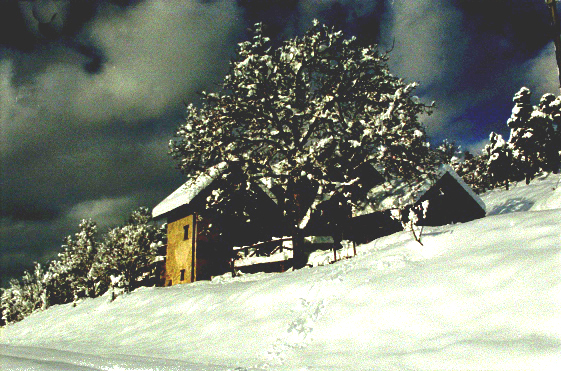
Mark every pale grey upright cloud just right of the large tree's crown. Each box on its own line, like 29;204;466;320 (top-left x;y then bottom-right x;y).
381;0;473;135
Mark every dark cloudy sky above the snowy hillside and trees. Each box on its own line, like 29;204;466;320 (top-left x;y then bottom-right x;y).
0;0;559;286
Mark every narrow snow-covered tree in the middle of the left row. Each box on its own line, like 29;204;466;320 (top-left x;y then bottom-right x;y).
47;219;98;304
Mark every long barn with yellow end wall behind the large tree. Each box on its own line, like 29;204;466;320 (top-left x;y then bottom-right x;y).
152;163;485;286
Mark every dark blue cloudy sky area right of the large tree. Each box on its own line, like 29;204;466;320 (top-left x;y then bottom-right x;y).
382;0;557;147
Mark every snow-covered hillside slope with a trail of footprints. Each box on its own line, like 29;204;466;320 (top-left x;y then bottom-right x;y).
0;175;561;371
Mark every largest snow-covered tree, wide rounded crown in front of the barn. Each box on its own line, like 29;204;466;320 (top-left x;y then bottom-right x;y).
170;21;429;267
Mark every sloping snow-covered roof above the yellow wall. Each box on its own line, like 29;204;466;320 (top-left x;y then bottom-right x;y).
152;162;228;218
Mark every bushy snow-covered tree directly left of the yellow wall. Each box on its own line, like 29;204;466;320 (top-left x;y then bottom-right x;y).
90;207;165;295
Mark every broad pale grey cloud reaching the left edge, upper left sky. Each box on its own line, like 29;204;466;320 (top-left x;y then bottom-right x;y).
0;0;241;147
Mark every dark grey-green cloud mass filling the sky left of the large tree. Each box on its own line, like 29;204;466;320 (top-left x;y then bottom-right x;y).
0;0;245;282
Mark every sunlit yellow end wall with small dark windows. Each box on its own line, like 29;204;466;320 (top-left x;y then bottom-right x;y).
165;215;197;286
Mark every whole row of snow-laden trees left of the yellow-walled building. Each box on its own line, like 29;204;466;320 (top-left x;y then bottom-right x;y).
0;208;165;323
